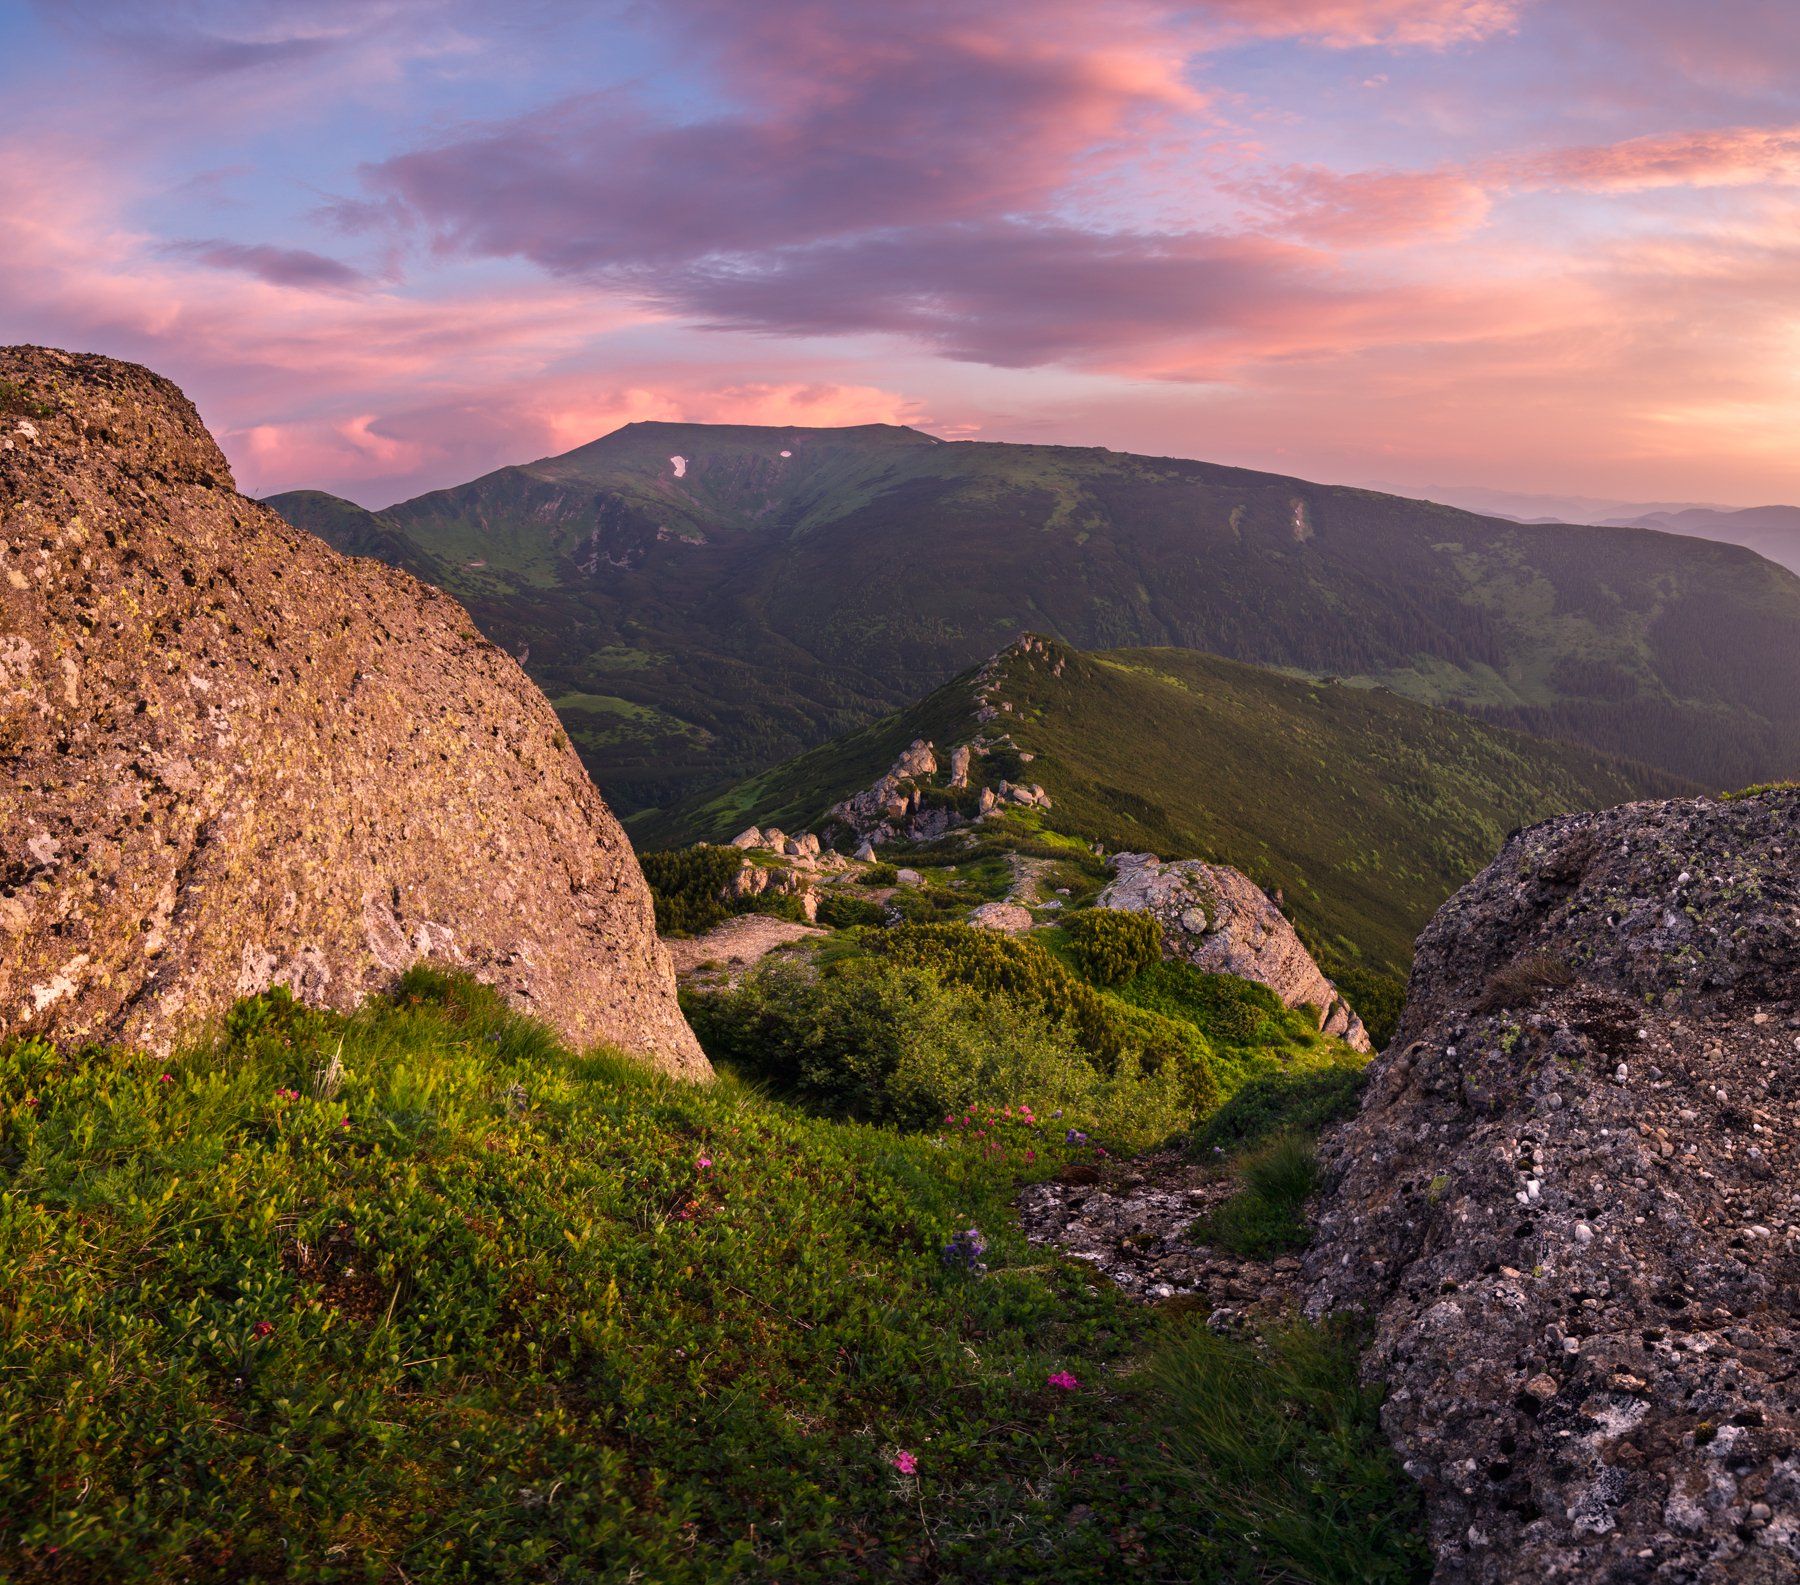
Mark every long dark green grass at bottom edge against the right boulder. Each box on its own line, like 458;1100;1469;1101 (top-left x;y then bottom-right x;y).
1145;1322;1431;1585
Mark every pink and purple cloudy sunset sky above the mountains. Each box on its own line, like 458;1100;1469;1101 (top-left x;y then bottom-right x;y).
0;0;1800;506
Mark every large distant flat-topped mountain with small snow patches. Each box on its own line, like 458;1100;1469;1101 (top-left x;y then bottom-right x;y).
275;425;1800;813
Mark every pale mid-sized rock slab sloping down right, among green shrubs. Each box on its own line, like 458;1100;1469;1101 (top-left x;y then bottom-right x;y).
1098;853;1370;1051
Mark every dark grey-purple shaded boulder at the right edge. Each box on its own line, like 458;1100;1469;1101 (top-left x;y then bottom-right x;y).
1307;790;1800;1585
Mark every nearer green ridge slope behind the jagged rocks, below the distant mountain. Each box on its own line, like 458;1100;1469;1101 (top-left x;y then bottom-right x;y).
655;644;1692;973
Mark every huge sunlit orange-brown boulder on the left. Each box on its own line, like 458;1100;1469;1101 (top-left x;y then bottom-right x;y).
0;347;709;1076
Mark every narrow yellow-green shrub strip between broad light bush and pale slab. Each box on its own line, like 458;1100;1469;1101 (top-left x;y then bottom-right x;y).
869;925;1219;1112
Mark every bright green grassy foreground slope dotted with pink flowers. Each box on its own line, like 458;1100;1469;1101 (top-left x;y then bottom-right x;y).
0;972;1425;1585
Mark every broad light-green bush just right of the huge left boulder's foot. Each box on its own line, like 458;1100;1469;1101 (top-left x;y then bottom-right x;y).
684;957;1195;1144
